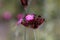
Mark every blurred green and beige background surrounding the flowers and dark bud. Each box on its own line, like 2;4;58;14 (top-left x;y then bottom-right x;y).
0;0;60;40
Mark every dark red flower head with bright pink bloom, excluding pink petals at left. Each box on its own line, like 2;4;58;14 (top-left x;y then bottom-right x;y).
21;14;45;29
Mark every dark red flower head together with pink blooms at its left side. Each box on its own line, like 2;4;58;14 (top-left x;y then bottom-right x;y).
17;14;45;29
